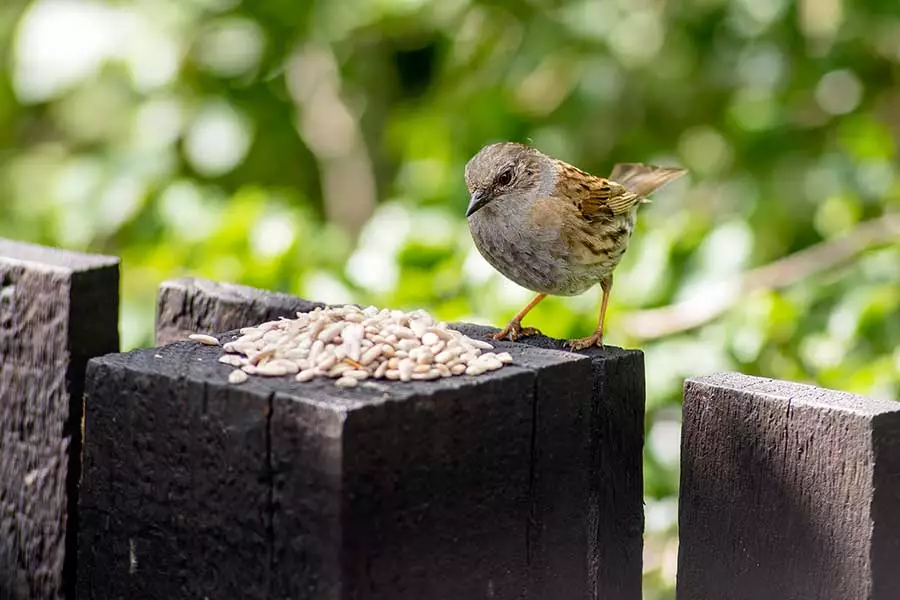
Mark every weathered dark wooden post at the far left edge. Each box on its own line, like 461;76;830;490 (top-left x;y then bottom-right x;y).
0;240;119;600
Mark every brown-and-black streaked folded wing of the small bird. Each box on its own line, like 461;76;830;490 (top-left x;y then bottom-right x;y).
554;161;647;222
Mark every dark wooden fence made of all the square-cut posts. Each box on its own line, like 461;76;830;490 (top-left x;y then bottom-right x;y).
0;241;900;600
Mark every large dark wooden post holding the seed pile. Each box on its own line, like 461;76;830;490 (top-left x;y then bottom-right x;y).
79;285;644;600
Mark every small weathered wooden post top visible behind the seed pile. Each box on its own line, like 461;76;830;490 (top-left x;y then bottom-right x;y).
156;277;322;346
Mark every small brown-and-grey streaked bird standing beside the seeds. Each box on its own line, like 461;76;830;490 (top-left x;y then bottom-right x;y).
466;142;687;350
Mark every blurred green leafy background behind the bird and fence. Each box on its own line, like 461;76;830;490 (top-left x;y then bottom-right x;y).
0;0;900;599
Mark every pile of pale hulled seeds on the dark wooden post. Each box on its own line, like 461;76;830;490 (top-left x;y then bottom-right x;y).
190;306;512;387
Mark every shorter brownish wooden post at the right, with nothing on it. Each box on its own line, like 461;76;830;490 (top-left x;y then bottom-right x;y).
678;374;900;600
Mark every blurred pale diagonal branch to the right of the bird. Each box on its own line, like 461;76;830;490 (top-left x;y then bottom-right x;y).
621;214;900;340
